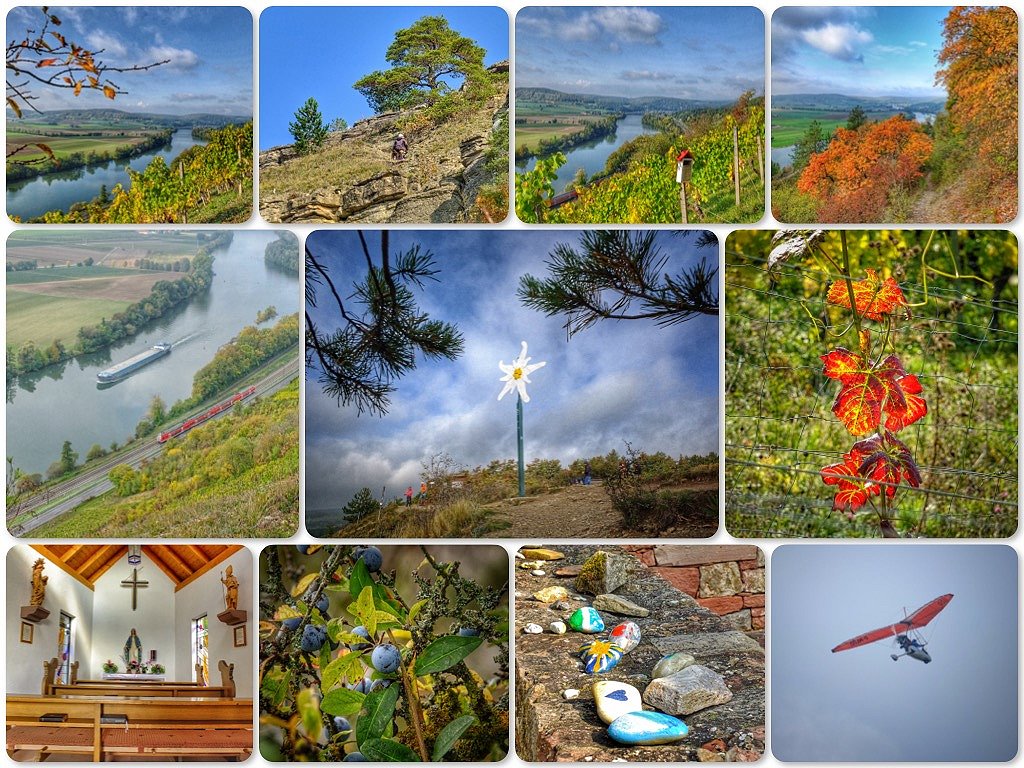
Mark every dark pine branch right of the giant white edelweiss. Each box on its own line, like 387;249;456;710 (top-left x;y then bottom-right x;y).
517;229;718;337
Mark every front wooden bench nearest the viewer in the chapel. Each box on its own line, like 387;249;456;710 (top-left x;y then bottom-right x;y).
7;695;253;762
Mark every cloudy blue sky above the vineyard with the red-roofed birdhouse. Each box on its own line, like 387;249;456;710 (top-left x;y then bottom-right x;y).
515;6;765;101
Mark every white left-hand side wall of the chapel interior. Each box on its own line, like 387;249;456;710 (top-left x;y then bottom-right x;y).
6;544;98;693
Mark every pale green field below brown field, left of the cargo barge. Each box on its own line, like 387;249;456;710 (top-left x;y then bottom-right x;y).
7;288;131;347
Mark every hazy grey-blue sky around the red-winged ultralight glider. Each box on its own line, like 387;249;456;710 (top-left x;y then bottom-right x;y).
771;544;1018;762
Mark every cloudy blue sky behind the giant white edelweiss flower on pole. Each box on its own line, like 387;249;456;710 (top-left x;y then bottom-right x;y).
305;229;719;509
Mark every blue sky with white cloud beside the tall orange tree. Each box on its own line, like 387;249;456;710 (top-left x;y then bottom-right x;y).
771;6;949;99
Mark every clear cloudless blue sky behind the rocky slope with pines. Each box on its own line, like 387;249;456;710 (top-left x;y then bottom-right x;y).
259;6;509;150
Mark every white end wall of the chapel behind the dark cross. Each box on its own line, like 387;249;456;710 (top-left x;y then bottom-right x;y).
91;550;175;680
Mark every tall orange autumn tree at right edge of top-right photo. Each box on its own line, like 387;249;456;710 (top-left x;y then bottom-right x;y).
935;6;1018;220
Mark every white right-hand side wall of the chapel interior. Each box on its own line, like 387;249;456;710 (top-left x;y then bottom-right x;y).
175;548;257;698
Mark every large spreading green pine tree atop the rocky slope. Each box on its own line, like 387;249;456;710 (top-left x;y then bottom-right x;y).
353;16;487;113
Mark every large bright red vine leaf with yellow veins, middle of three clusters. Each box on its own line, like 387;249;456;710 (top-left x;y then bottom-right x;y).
821;347;928;437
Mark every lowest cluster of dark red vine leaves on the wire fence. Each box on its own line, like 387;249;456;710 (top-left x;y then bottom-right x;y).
821;432;921;512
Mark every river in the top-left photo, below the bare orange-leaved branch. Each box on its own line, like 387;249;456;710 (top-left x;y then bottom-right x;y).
7;129;206;221
